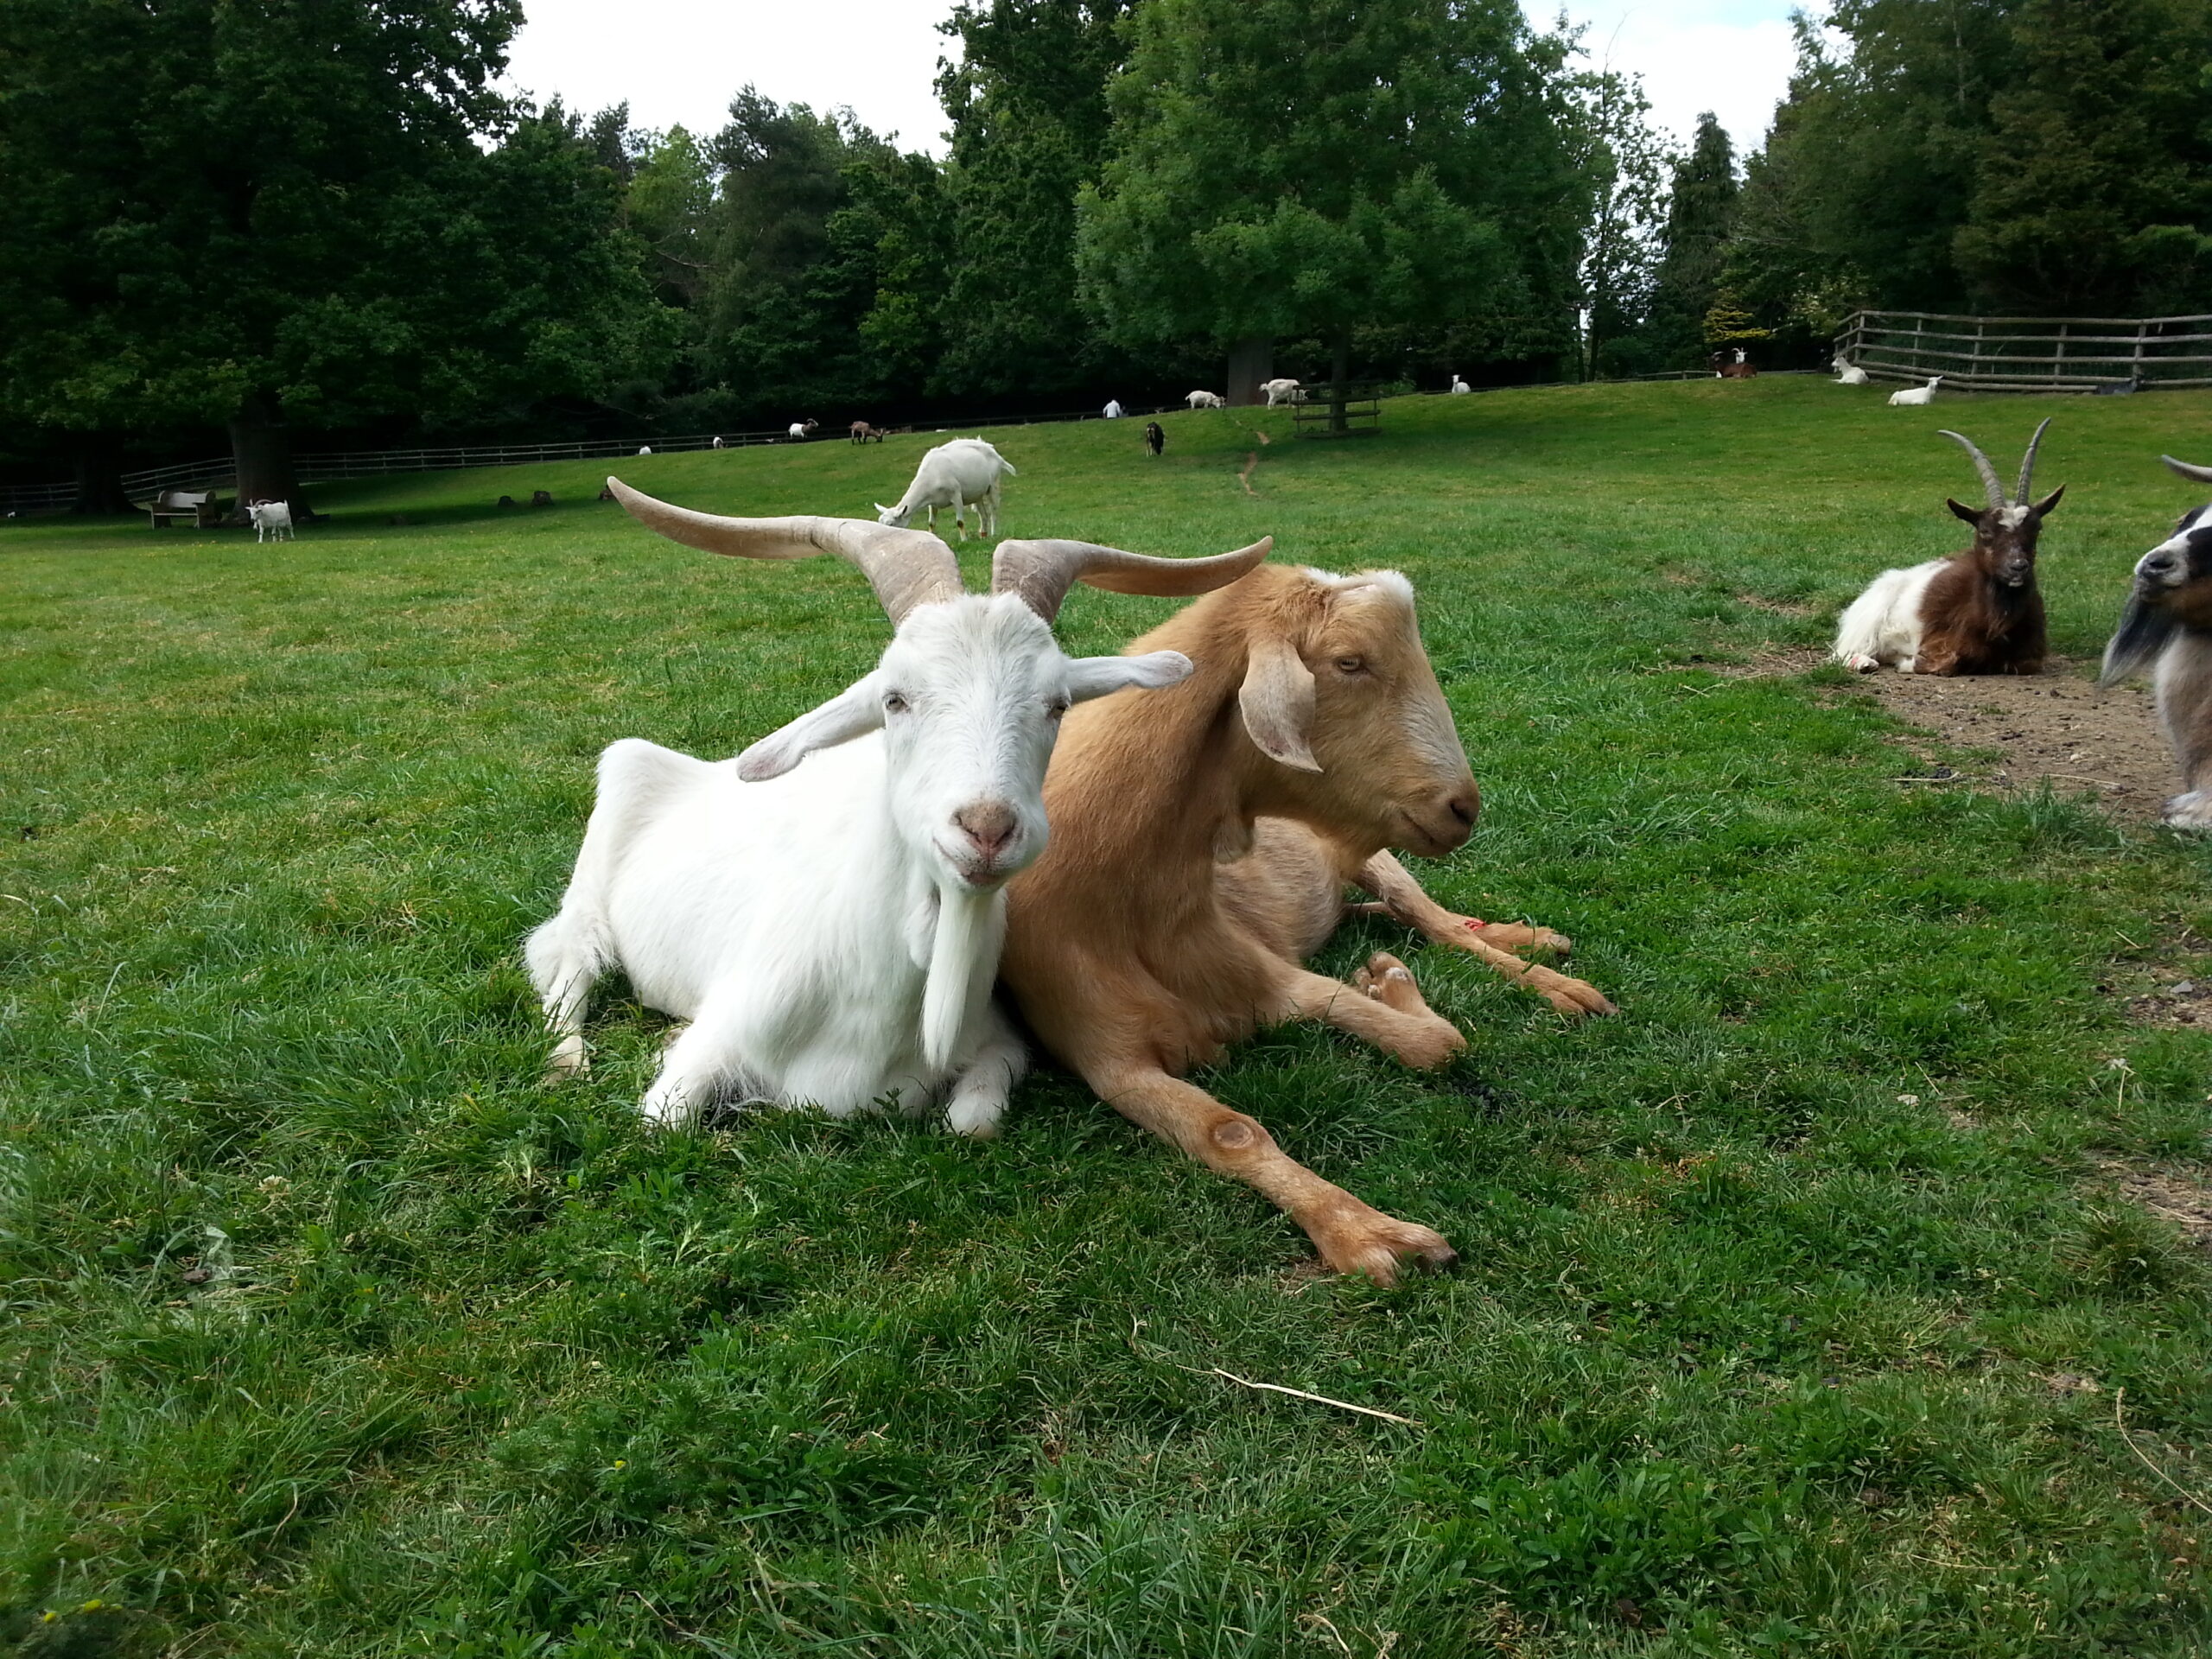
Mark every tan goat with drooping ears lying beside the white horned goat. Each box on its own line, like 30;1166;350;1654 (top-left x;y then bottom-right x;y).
1000;564;1612;1283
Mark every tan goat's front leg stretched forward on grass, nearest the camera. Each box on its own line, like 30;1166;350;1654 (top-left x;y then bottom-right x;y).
1084;1065;1455;1285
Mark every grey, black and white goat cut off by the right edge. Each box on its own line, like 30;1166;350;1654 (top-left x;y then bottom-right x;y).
2097;455;2212;830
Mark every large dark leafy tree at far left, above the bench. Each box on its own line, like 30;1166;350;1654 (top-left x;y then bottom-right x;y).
0;0;661;502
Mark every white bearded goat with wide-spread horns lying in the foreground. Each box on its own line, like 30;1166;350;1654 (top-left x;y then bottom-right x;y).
524;478;1269;1135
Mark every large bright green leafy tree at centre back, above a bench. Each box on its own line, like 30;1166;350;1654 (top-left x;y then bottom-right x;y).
1077;0;1588;398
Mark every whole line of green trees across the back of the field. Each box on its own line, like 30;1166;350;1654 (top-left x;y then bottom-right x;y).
0;0;2212;506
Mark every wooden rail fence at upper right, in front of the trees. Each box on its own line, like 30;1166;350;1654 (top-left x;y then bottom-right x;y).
1836;312;2212;391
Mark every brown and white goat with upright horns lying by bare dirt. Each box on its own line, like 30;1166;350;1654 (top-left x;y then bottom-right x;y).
1832;420;2066;675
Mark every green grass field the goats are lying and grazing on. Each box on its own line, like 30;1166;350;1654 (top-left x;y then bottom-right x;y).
0;378;2212;1659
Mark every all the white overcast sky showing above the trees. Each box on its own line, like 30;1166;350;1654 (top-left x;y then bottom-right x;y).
511;0;1792;155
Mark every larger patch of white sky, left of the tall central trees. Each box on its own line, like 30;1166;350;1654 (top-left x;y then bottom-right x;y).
506;0;957;155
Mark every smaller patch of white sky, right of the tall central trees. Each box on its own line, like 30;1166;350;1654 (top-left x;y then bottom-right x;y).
1529;0;1796;159
